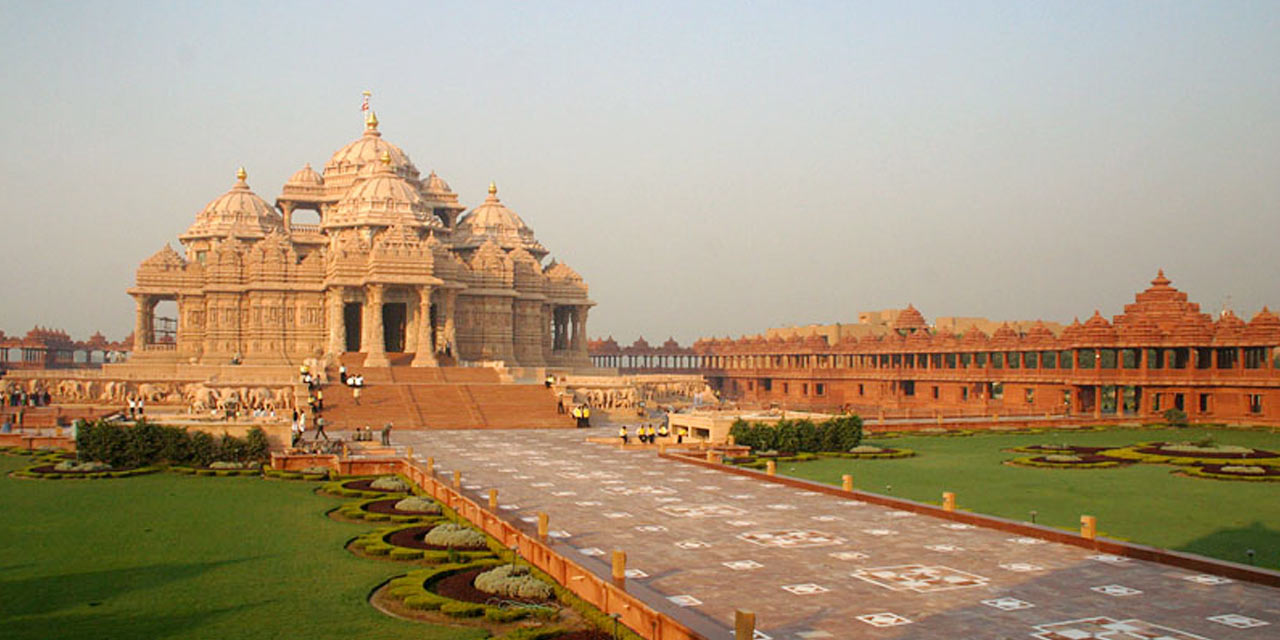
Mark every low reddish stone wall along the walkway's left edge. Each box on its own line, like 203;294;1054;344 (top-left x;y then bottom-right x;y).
271;454;727;640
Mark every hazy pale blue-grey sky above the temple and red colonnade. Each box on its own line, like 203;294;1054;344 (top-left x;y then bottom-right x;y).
0;0;1280;342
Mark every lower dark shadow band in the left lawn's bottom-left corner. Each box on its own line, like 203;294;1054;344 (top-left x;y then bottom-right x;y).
4;603;261;640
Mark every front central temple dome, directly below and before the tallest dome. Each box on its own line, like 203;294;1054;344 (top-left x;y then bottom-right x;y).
324;152;439;229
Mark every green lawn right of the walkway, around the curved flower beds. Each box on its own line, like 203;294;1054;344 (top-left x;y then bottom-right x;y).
778;428;1280;568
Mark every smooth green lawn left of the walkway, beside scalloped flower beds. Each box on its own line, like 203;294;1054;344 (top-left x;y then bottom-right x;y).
0;456;484;640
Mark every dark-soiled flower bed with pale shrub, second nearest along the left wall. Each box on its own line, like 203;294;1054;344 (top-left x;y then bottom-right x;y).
351;522;493;563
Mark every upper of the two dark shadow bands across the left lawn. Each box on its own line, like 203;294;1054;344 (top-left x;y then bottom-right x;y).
0;558;262;619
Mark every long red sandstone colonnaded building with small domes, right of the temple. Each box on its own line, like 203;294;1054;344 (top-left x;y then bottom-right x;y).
591;271;1280;424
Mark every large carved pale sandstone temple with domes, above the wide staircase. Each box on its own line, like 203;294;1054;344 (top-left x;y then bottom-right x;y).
129;113;594;367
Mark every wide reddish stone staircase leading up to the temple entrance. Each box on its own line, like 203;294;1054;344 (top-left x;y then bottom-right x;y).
314;353;573;430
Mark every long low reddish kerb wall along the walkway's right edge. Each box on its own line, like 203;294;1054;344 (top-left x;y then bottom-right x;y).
659;453;1280;586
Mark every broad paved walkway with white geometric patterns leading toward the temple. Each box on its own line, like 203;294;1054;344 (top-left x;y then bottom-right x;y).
396;430;1280;640
